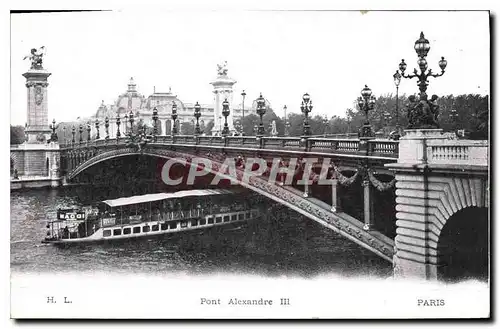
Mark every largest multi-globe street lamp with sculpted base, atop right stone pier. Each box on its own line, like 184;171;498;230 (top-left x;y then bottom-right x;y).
399;32;448;129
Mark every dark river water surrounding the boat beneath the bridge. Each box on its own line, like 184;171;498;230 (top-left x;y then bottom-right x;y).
10;187;392;278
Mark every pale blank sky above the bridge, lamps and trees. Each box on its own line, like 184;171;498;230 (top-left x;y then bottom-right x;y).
10;8;490;125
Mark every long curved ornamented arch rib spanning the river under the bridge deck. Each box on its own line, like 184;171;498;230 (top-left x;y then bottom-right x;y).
67;147;394;262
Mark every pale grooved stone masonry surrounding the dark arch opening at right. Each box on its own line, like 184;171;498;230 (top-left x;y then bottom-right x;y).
395;170;489;272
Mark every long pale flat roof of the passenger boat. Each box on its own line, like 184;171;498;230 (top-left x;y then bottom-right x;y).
102;189;235;207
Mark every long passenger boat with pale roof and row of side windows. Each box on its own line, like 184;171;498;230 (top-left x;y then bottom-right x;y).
42;189;260;244
